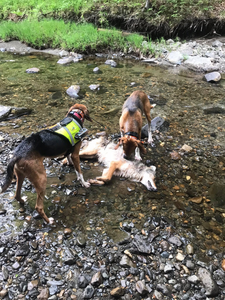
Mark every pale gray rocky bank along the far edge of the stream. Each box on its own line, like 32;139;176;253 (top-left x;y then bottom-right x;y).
0;37;225;73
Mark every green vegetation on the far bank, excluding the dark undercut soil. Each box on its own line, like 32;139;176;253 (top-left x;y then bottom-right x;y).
0;0;225;53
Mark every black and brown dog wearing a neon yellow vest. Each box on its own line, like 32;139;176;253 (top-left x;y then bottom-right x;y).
0;104;92;223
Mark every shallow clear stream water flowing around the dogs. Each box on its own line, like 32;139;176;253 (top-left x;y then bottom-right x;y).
0;53;225;253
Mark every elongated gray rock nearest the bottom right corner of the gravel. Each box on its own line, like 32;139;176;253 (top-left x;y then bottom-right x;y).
198;268;219;297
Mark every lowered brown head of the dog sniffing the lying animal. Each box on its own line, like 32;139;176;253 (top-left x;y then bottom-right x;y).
115;136;146;159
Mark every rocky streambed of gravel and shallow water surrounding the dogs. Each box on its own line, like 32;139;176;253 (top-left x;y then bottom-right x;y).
0;38;225;300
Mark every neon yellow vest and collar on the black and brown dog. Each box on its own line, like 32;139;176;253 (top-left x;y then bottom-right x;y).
48;109;87;147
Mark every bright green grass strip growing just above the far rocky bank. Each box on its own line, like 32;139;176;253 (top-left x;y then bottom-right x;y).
0;20;154;52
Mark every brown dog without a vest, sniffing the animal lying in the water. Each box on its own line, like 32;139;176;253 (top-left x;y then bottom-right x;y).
116;91;154;160
